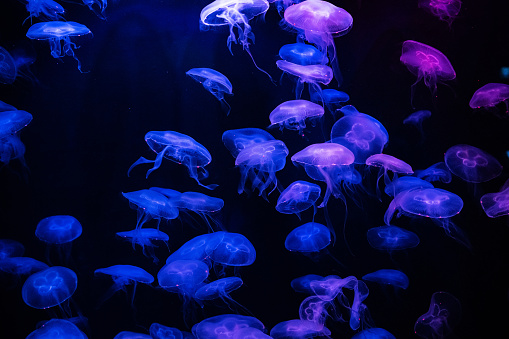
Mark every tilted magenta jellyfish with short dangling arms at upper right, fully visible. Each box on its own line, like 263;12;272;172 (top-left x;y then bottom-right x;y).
399;40;456;104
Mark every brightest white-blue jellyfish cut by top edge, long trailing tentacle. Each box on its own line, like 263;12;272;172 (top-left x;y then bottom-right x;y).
200;0;272;80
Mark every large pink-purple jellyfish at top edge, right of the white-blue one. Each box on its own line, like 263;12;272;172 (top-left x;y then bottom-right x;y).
284;0;353;84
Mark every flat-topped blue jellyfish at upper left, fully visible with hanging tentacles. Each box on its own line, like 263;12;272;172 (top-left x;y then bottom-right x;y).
27;21;92;73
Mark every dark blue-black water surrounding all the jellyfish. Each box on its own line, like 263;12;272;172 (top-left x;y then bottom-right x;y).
0;0;509;338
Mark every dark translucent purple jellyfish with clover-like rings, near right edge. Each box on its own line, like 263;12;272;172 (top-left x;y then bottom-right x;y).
444;145;502;183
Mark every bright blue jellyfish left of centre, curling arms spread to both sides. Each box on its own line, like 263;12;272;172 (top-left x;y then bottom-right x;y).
127;131;217;190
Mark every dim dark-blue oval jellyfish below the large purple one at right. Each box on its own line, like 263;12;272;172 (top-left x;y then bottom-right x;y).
367;225;420;252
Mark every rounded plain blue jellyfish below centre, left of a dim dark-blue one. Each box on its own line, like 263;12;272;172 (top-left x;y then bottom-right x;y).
285;222;331;253
